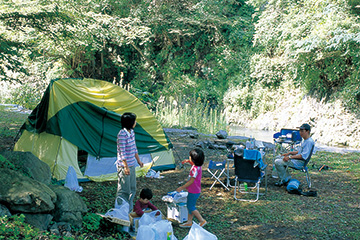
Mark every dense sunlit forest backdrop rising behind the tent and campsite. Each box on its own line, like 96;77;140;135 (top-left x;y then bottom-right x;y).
0;0;360;146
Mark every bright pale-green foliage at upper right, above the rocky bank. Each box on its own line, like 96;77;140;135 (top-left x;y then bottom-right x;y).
252;0;360;102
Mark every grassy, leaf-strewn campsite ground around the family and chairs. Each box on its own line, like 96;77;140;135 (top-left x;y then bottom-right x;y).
0;106;360;239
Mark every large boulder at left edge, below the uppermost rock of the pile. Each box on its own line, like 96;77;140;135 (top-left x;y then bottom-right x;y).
0;168;56;213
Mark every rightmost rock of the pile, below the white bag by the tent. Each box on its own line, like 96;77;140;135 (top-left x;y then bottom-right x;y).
50;185;87;228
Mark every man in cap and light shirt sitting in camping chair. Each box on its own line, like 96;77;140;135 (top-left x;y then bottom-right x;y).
275;123;315;187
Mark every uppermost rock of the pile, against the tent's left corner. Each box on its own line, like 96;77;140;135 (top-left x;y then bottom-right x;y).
2;151;51;185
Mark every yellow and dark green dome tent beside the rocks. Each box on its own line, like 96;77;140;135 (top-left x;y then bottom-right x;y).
14;78;175;181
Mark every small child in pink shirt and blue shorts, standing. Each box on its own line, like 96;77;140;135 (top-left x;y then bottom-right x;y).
176;148;207;228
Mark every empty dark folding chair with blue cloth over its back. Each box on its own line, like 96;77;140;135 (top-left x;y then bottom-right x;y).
234;149;267;202
